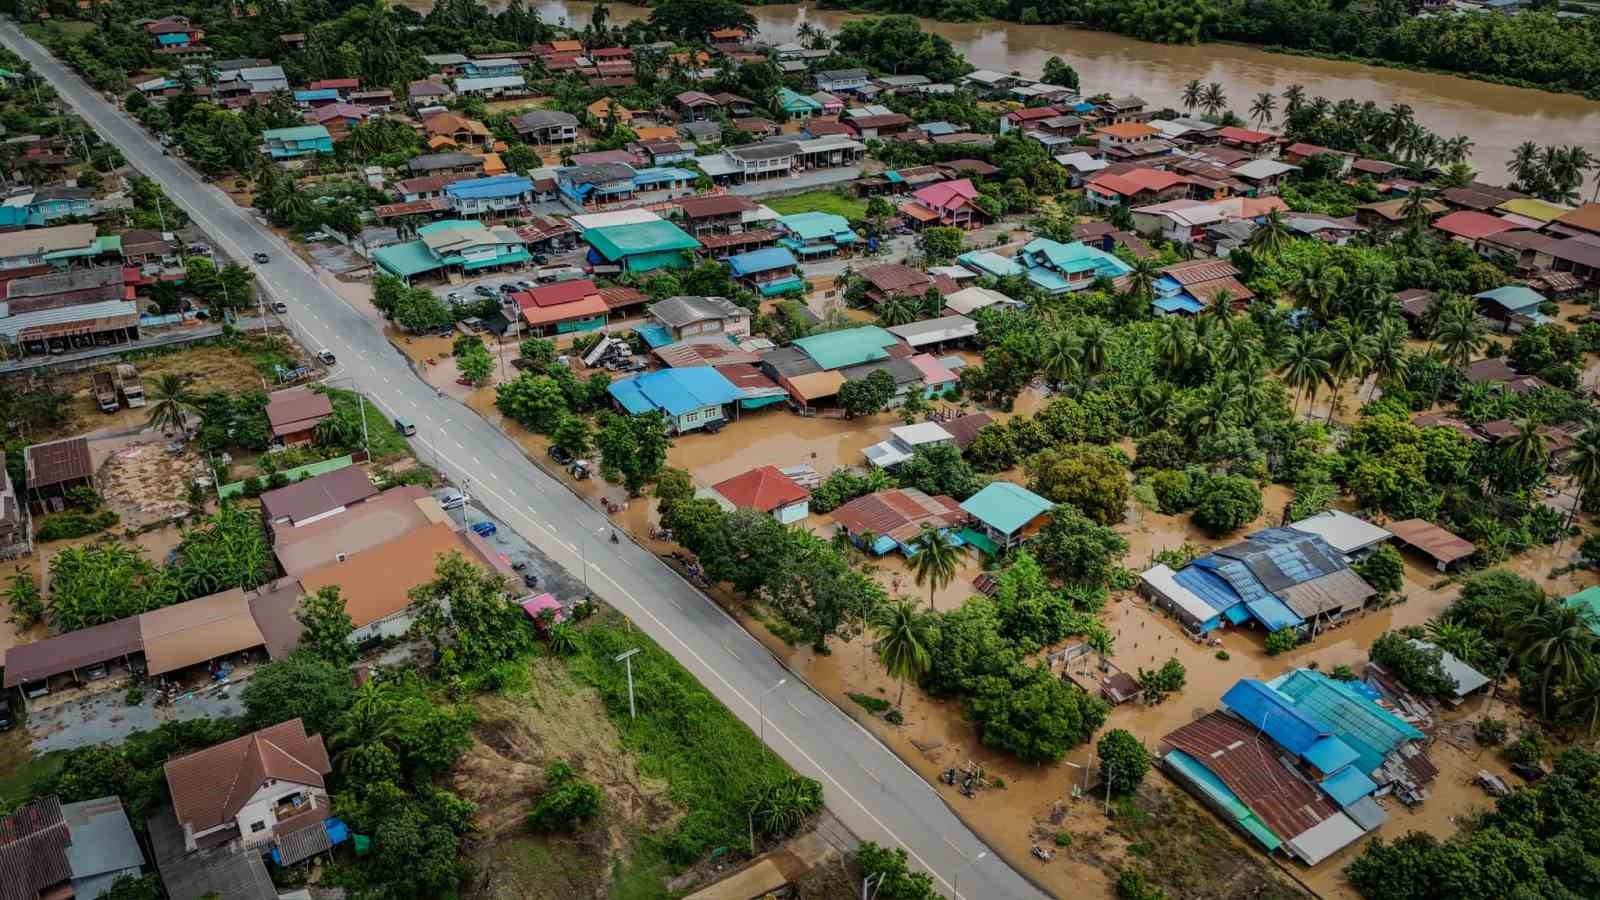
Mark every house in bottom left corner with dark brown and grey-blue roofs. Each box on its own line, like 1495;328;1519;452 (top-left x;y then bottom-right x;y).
0;796;144;900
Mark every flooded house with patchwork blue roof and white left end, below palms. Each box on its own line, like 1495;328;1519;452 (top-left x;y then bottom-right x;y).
1139;528;1378;636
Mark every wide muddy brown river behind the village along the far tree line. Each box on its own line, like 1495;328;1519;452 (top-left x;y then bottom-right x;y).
405;0;1600;183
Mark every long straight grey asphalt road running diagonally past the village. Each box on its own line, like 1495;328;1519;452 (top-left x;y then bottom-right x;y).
0;21;1043;900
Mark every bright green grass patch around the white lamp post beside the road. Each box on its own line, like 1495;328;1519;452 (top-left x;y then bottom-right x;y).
566;612;789;871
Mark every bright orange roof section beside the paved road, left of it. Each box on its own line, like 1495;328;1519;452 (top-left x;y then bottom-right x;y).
299;524;470;628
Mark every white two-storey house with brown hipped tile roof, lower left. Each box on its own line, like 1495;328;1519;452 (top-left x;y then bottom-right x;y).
163;719;333;852
